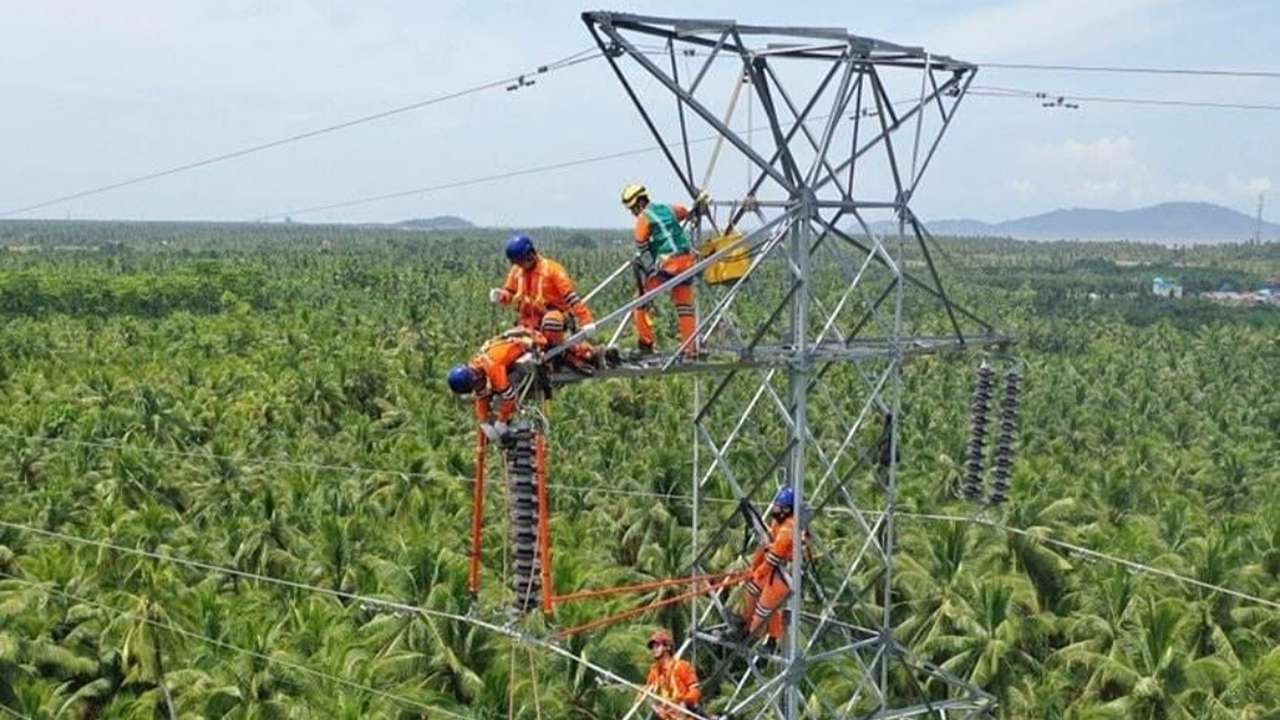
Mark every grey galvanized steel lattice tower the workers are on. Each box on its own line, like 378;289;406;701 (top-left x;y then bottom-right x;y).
576;12;1010;720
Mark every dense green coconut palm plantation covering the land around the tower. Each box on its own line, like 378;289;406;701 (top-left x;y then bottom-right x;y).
0;223;1280;720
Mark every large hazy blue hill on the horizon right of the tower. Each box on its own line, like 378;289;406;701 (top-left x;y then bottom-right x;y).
877;202;1280;242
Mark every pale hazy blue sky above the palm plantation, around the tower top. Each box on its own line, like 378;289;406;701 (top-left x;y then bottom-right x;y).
0;0;1280;227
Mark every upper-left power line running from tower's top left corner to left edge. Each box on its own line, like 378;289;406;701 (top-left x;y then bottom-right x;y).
0;49;599;218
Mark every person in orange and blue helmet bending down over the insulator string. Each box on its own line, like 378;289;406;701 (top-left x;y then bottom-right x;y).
448;327;547;441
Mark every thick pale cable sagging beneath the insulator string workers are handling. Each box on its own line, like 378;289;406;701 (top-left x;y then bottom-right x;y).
0;520;708;720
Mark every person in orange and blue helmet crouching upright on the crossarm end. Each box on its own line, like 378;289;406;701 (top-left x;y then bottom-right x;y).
489;234;599;372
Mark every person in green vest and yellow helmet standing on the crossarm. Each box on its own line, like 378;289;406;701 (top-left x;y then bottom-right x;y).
622;184;707;357
